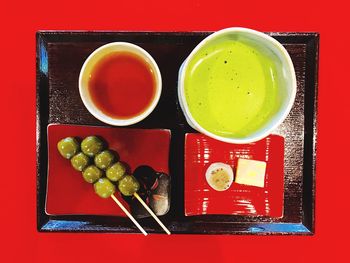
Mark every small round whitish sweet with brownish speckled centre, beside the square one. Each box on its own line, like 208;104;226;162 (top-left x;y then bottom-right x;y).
205;163;233;191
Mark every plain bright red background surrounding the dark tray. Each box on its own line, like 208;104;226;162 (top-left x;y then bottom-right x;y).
0;0;350;262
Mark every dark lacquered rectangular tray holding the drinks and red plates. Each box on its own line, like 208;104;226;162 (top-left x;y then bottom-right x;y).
36;31;319;235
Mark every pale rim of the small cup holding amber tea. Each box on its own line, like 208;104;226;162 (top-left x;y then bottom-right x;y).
79;41;162;126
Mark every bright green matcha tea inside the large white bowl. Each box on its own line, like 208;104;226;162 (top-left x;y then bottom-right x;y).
184;38;282;138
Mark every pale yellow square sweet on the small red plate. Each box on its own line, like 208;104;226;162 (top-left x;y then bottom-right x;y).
235;159;266;187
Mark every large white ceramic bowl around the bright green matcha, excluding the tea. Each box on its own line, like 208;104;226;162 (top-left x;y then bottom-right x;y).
178;27;297;144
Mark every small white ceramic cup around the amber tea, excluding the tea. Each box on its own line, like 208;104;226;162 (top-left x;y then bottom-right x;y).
79;42;162;126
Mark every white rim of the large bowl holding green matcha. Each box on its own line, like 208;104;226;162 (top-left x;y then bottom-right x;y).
178;27;297;144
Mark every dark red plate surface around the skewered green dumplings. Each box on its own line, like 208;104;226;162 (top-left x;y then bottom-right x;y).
46;125;170;217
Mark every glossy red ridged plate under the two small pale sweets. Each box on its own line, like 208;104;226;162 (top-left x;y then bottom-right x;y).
185;133;284;217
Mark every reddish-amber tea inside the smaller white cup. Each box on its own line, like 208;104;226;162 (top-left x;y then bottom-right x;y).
88;52;156;119
